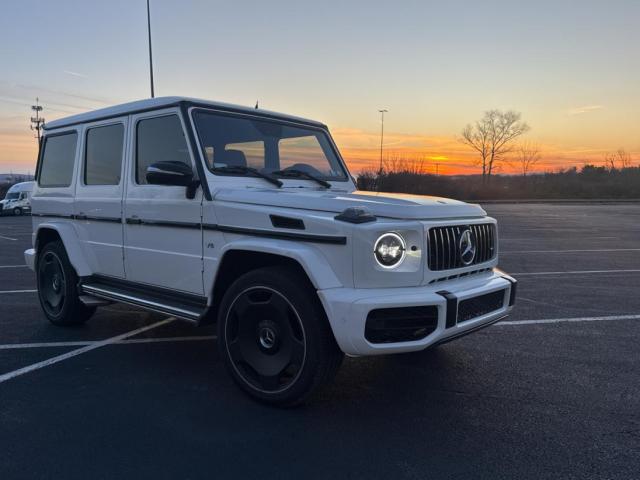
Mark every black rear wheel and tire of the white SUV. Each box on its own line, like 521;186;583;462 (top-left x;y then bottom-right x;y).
36;241;96;326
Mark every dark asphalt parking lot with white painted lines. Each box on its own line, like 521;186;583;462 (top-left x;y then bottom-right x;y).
0;204;640;480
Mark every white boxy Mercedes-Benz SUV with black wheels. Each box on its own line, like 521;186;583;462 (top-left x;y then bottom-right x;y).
25;97;516;405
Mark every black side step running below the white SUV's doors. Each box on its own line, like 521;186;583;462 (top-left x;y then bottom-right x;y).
80;276;207;324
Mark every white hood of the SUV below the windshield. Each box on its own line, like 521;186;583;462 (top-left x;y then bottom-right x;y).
215;188;486;220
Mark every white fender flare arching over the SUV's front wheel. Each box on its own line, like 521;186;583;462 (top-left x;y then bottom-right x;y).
214;238;343;290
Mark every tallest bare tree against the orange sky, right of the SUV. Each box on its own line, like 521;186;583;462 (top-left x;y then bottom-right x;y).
460;110;529;181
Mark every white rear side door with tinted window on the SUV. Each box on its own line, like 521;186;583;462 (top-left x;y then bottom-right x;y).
75;117;128;278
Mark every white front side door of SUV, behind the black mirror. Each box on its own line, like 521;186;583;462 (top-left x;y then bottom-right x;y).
124;109;204;294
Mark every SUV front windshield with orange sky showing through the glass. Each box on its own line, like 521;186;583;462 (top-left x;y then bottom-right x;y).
194;111;347;181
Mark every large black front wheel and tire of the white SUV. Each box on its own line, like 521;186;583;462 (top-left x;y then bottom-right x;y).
218;267;344;407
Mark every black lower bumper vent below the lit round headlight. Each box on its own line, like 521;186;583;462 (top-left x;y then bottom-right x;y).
364;306;438;343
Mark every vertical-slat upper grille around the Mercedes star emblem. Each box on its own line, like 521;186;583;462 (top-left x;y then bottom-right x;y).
427;223;496;270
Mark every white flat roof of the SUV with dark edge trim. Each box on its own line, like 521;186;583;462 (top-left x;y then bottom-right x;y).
44;97;324;130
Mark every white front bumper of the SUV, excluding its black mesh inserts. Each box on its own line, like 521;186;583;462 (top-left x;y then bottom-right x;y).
318;269;516;355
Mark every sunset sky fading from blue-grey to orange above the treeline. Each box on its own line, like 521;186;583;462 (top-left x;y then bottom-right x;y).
0;0;640;173
